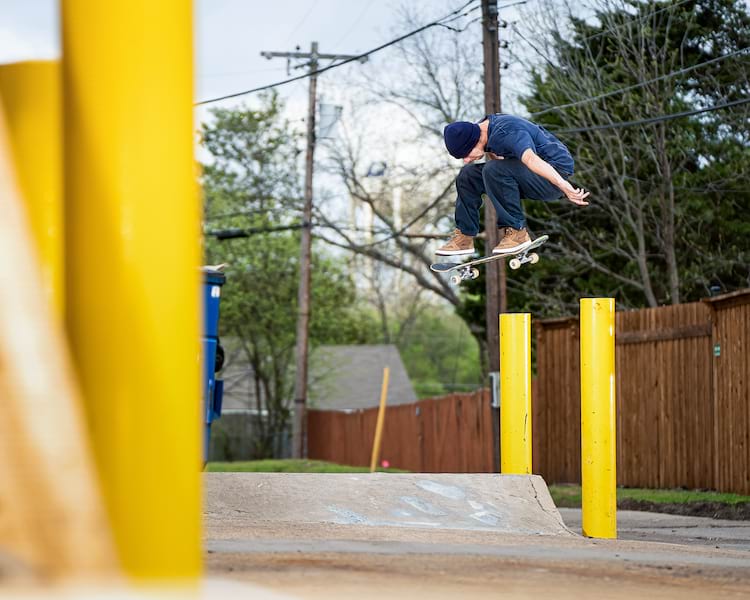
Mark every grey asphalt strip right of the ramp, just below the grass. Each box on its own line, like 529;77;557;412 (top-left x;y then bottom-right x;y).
559;508;750;551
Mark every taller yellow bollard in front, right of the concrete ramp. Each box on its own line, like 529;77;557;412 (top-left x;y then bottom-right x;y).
581;298;617;538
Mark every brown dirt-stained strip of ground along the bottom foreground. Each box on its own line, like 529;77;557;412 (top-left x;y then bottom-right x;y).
207;553;750;600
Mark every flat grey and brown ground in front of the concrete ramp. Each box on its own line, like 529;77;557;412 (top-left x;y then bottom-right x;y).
206;519;750;600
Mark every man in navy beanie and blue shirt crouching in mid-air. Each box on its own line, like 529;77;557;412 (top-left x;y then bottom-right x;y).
435;114;589;255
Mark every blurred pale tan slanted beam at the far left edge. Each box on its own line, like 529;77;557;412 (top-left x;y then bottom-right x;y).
0;89;118;580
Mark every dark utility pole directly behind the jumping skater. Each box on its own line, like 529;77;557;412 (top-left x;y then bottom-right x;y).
482;0;508;473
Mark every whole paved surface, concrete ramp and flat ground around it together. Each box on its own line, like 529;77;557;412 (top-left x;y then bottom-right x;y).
198;473;750;600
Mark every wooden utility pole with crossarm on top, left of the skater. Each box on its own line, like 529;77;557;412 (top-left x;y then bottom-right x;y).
260;42;367;458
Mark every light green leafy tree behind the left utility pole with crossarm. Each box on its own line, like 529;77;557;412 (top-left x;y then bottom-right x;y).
201;95;382;456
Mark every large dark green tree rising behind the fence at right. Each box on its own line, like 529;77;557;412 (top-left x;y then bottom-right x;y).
511;0;750;314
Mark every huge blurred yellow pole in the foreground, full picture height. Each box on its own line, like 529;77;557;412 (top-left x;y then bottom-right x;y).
61;0;201;581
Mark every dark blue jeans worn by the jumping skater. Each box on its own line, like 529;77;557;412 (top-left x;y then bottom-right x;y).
456;158;570;236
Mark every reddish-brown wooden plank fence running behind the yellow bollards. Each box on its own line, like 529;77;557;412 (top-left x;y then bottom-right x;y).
309;290;750;494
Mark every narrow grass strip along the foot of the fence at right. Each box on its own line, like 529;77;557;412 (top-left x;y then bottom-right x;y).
549;484;750;508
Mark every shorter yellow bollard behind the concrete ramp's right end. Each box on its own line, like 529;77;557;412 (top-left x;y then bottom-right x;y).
500;313;531;475
